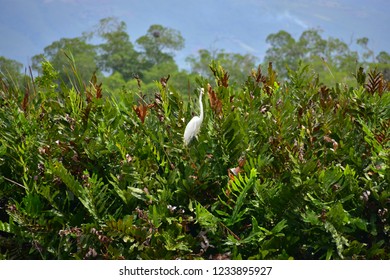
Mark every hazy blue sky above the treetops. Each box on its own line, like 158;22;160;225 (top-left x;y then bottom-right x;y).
0;0;390;68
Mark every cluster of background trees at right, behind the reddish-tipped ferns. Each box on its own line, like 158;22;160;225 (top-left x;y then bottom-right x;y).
264;29;362;83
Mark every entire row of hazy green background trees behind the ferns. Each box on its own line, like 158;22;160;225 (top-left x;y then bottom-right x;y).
2;17;390;92
